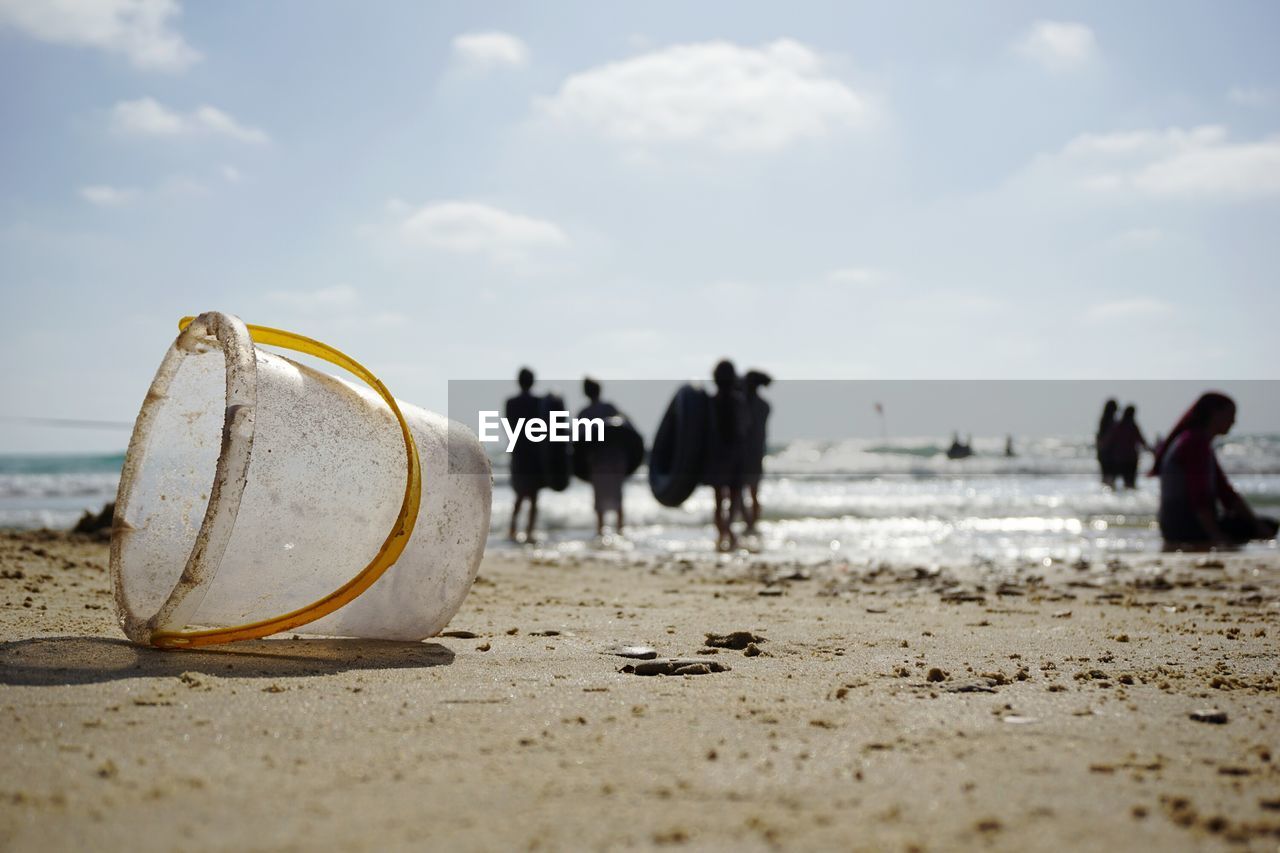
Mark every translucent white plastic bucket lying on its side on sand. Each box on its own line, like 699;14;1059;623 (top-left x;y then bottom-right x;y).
111;313;493;648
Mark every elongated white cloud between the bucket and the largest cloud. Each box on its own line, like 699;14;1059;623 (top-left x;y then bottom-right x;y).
394;201;570;260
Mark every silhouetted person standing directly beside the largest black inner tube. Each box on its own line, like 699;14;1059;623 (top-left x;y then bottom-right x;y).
705;359;750;551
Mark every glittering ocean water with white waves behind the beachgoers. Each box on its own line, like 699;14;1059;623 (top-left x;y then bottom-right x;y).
12;435;1280;565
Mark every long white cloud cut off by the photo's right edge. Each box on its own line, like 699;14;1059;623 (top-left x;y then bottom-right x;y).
1032;124;1280;200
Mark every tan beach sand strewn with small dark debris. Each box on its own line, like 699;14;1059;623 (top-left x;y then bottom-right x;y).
0;533;1280;850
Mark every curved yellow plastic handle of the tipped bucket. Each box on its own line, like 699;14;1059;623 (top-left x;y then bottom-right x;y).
151;316;422;648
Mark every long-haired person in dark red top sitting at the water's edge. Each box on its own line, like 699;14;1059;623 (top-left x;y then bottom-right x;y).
1151;391;1277;548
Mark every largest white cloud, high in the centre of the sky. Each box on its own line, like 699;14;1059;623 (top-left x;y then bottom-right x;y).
540;38;872;151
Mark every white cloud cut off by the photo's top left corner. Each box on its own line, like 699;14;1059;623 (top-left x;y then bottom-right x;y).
0;0;201;72
